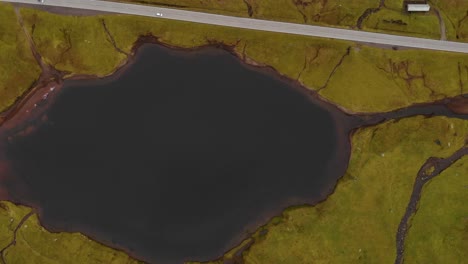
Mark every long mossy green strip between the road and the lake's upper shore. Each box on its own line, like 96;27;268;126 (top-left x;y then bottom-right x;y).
13;6;468;112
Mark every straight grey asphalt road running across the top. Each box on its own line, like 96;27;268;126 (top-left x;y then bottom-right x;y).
0;0;468;53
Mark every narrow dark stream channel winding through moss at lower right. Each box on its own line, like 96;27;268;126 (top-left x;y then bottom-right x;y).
395;145;468;264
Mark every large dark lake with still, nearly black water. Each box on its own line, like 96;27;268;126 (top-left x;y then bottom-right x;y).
3;42;349;263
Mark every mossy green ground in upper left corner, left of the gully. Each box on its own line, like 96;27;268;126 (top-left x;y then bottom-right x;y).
0;3;40;111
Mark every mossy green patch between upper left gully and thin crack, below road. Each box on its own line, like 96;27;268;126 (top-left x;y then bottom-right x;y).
21;9;126;76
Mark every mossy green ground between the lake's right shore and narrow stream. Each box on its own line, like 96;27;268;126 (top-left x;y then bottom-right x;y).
239;117;468;263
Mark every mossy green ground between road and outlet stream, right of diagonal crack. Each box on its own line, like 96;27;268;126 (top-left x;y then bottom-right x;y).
320;46;468;112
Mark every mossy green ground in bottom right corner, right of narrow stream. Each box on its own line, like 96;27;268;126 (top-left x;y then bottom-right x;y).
405;156;468;263
